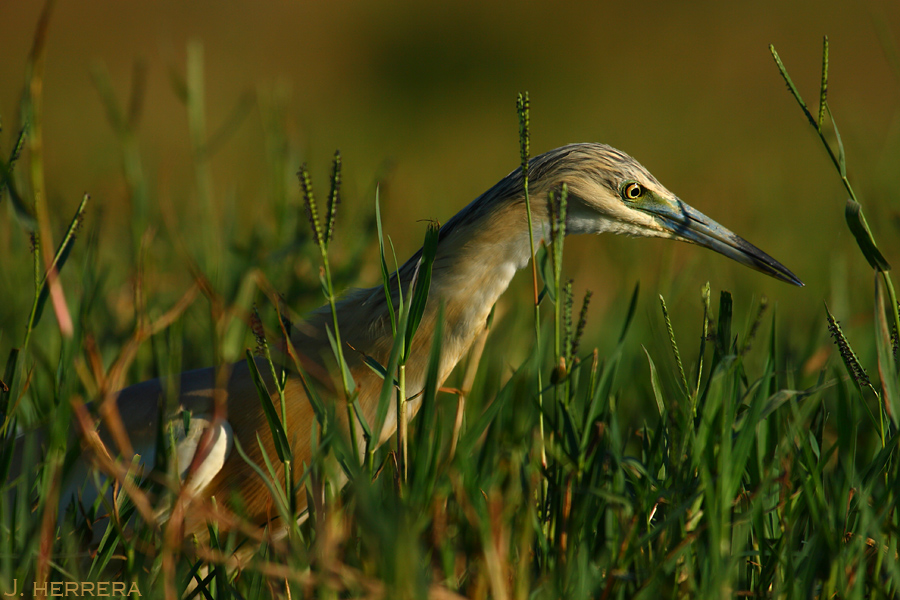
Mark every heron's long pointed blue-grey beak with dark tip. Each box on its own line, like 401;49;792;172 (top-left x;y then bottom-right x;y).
644;200;803;287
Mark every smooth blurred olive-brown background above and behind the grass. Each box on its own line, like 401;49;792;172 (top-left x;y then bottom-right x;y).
0;0;900;386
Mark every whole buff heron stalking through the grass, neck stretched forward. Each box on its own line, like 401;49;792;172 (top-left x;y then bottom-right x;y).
17;143;803;531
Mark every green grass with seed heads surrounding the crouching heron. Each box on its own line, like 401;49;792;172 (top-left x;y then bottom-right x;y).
0;16;900;598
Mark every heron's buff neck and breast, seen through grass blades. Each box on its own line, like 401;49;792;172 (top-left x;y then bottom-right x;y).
294;201;547;446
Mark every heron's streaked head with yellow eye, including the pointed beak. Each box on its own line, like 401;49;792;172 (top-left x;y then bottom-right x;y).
548;144;803;286
